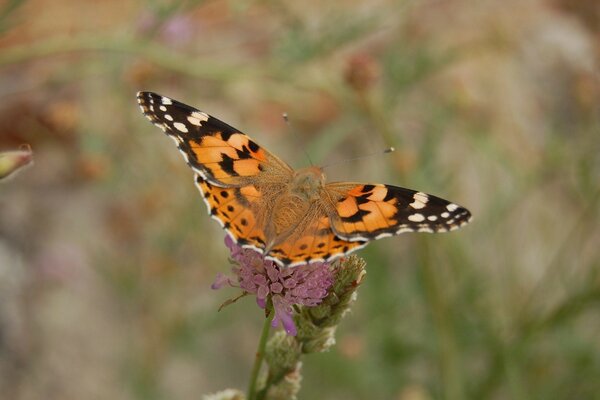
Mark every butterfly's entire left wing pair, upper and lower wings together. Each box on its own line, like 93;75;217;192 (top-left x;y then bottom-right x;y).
137;92;293;250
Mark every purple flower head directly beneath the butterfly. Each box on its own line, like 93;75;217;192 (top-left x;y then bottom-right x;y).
212;235;333;336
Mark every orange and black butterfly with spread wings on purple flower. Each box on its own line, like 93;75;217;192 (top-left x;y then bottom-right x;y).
137;92;471;267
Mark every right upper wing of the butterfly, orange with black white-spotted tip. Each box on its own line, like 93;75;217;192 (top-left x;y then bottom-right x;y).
326;183;471;241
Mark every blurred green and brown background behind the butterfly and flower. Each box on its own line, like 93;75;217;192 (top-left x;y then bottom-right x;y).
0;0;600;400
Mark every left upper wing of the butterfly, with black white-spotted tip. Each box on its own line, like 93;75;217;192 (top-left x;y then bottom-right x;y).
137;92;293;187
